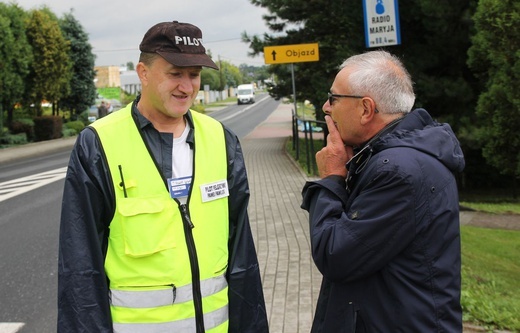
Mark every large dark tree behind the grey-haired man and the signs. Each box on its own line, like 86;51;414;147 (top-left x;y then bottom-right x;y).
246;0;477;123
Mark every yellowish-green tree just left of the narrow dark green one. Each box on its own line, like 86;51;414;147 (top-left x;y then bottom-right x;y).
26;7;72;116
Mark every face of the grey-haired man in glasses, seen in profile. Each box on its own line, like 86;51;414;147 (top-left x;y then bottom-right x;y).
323;68;364;146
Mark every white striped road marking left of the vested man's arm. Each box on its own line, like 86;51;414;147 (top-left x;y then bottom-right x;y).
0;167;67;202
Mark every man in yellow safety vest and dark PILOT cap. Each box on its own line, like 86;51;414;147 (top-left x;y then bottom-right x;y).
58;21;268;333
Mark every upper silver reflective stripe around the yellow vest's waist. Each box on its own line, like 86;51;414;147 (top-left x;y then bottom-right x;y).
110;275;227;308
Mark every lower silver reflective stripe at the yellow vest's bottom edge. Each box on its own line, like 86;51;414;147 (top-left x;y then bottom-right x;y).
114;306;228;333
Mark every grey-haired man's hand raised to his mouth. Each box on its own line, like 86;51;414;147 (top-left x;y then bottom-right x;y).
316;115;353;178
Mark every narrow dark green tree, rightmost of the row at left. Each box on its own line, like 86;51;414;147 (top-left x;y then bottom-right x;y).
59;12;97;115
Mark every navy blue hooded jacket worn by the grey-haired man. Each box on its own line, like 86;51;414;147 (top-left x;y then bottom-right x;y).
302;109;464;333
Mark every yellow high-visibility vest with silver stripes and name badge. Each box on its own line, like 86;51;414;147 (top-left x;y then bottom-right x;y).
91;105;229;333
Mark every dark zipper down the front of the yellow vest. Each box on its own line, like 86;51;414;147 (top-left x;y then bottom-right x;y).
179;204;205;333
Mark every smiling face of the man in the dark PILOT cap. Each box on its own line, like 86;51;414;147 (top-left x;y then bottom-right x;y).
137;57;202;121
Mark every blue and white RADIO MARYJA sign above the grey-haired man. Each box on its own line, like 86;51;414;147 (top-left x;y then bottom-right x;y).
363;0;401;48
